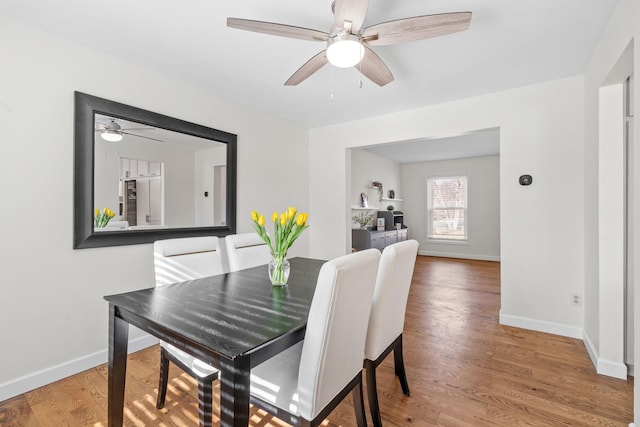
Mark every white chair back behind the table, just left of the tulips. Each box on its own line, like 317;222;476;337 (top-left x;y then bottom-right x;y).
224;233;271;271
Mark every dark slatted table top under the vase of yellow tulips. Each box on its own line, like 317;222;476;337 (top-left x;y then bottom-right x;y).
104;258;324;359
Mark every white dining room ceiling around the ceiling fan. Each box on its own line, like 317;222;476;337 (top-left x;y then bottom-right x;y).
0;0;617;127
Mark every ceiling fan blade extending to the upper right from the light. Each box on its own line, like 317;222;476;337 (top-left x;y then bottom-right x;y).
363;12;471;46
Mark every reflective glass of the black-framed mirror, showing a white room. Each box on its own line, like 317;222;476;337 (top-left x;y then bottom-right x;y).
94;114;226;231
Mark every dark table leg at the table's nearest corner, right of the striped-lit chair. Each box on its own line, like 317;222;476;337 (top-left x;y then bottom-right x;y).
220;357;251;427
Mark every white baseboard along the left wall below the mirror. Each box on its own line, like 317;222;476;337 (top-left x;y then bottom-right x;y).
0;335;159;402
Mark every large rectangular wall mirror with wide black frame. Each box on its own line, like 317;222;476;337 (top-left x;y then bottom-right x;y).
73;92;237;249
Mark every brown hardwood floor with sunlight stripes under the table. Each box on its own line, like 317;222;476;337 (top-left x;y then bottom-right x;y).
0;257;633;427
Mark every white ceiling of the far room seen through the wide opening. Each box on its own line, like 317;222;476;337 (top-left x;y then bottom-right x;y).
363;129;500;163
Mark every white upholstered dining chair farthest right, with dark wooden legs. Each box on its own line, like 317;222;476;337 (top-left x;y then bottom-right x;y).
364;240;418;427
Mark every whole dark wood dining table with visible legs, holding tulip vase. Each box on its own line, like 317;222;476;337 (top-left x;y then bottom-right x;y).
104;258;324;427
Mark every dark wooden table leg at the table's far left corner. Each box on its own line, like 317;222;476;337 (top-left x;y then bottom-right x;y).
107;304;129;427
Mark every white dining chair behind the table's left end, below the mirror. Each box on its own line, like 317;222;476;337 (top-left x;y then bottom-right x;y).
153;236;224;426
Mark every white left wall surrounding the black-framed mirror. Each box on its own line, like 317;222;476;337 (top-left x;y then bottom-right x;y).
0;15;315;400
